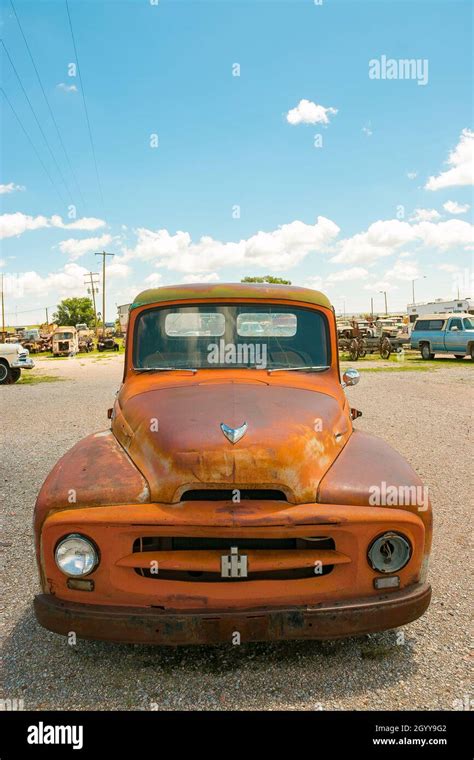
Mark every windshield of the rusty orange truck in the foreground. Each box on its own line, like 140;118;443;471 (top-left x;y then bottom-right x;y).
133;303;330;370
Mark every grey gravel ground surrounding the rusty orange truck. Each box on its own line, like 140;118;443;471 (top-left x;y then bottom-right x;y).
0;355;473;710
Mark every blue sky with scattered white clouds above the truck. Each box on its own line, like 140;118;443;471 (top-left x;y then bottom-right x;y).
0;0;474;324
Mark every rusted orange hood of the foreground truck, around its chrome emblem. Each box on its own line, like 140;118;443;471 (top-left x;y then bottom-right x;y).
112;380;352;503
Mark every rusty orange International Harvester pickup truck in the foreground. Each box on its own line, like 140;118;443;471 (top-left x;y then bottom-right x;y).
34;283;431;645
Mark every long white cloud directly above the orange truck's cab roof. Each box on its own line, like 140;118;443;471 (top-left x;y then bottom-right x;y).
122;216;339;275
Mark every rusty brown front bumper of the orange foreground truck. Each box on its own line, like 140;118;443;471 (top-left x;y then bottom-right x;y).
34;583;431;645
